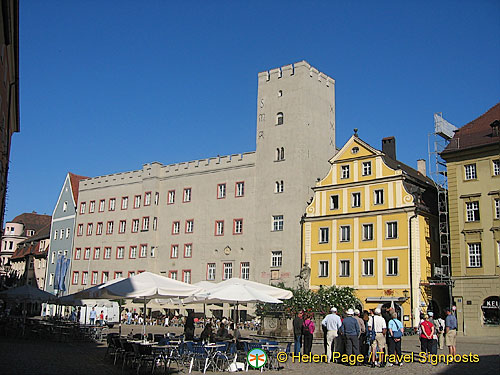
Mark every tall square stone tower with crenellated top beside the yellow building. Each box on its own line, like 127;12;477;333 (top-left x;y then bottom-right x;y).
254;61;335;285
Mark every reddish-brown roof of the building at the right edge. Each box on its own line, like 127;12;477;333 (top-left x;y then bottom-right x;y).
441;102;500;155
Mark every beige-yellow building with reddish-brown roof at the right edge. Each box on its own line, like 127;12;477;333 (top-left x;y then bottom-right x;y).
441;103;500;336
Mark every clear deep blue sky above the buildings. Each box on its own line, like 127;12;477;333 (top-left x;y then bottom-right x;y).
5;0;500;220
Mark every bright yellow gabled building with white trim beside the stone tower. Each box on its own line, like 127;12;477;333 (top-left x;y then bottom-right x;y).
302;134;445;326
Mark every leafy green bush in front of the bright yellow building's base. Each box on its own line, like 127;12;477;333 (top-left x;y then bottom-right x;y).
256;284;361;318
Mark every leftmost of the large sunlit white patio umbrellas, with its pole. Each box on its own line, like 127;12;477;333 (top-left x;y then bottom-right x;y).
94;272;200;337
